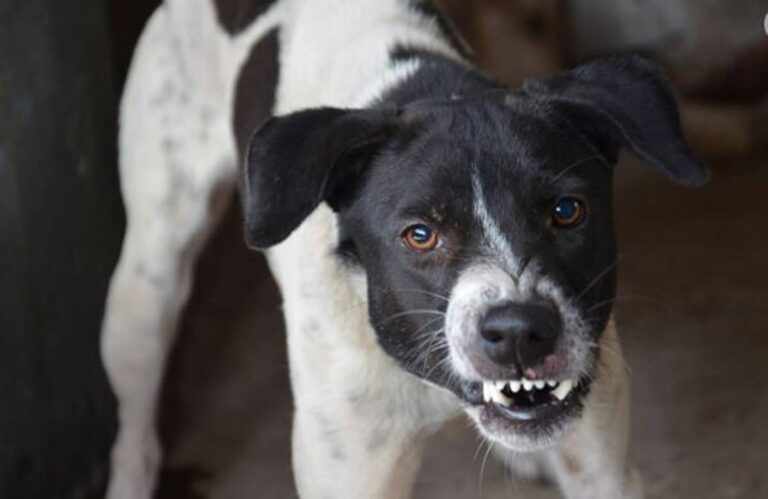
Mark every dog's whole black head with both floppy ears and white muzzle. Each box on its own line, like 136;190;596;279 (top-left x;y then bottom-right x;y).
246;57;707;450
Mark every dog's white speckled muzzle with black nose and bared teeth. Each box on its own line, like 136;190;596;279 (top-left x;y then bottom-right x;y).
446;266;593;450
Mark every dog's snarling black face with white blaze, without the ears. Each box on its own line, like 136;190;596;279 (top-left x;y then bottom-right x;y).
340;101;616;448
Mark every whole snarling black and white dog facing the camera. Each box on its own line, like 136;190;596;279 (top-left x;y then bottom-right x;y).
103;0;707;499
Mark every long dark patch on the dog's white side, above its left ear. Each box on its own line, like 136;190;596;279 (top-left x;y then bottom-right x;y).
233;29;280;158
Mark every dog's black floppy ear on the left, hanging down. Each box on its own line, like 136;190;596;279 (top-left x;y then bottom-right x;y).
244;108;397;248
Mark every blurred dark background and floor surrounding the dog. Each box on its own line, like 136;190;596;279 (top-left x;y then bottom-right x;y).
0;0;768;499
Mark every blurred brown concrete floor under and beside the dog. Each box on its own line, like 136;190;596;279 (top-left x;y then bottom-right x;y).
158;154;768;499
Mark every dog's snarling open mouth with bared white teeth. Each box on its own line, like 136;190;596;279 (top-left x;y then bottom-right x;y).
464;378;589;442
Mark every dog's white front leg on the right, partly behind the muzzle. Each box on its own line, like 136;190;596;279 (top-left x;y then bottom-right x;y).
548;322;643;499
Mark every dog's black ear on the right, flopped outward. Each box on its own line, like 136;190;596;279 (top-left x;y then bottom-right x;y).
523;56;709;186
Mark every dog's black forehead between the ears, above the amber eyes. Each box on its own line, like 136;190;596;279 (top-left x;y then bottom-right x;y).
370;100;595;207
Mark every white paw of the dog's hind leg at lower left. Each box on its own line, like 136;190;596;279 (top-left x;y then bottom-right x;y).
106;431;161;499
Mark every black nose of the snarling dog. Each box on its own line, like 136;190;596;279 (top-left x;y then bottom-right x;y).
480;303;561;368
